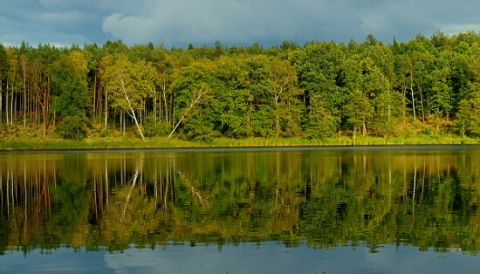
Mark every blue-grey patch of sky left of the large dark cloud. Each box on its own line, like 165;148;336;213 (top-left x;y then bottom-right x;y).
0;0;107;45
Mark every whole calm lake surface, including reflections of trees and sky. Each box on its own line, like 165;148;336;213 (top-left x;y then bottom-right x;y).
0;146;480;273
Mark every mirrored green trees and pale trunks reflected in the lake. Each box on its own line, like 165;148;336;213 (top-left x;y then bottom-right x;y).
0;146;480;254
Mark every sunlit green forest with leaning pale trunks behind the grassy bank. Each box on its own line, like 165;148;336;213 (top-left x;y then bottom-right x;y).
0;31;480;142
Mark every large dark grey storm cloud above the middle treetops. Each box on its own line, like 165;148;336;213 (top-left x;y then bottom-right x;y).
103;0;361;45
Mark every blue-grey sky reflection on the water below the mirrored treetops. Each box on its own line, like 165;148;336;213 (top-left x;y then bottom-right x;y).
0;242;480;274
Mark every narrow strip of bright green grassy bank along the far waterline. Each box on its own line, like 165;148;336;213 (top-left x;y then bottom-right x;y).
0;135;480;150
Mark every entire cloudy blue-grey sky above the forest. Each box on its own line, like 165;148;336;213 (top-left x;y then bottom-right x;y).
0;0;480;48
